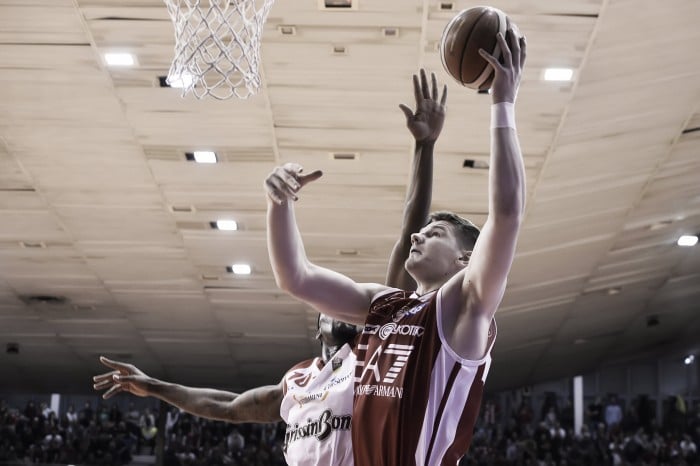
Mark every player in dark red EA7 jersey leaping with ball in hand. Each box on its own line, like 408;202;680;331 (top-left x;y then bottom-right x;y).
265;29;525;466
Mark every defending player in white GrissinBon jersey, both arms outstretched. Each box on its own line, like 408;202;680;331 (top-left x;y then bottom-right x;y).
93;70;447;466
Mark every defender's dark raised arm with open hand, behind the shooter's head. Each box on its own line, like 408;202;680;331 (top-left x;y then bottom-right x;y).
386;69;447;290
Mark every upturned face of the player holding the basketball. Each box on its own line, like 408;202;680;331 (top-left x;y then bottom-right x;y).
406;220;464;277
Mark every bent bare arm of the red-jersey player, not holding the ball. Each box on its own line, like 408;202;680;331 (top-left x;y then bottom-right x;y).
265;164;385;324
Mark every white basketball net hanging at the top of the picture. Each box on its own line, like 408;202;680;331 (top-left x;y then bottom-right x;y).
163;0;274;100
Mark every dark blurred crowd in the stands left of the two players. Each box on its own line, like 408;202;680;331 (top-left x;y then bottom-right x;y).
0;400;285;466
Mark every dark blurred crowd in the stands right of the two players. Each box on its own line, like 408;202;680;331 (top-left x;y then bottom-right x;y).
460;394;700;466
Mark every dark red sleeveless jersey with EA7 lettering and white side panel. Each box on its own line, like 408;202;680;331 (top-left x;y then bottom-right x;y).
352;289;496;466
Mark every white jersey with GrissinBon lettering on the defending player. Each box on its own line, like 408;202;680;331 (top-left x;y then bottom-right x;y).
280;344;356;466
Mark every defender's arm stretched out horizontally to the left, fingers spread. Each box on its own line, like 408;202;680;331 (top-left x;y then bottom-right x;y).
93;357;283;423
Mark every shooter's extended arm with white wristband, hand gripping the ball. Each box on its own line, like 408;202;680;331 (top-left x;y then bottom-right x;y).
443;29;525;359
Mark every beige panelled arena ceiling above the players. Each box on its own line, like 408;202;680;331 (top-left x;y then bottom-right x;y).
0;0;700;393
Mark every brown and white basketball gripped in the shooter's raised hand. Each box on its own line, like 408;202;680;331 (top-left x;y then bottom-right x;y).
440;6;520;90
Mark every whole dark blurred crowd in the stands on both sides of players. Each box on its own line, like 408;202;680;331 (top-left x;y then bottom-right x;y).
0;393;700;466
